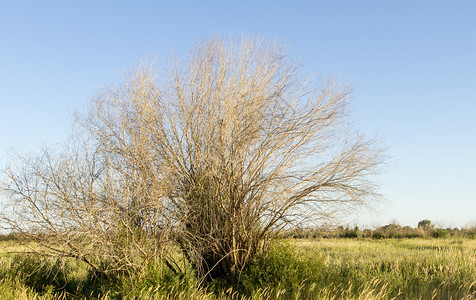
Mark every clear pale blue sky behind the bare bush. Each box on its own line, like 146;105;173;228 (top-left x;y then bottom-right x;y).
0;0;476;227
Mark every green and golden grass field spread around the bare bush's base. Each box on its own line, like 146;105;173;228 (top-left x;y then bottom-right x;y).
0;239;476;299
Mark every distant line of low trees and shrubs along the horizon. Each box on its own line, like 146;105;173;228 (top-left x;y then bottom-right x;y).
283;220;476;239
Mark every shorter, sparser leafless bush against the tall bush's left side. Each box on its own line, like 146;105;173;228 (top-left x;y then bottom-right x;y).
2;141;173;276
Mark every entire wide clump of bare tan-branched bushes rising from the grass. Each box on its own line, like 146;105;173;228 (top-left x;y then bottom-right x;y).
0;38;382;283
